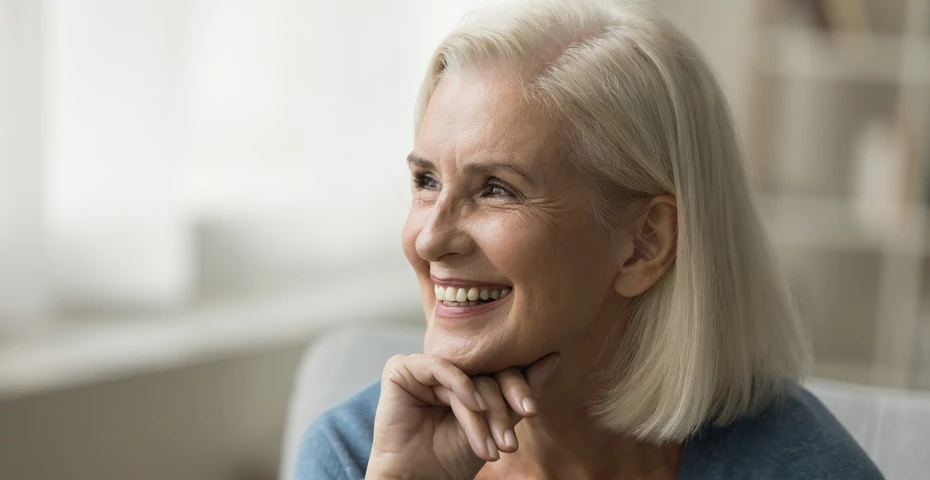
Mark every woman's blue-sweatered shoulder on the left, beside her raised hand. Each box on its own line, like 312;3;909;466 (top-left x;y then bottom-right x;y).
294;382;381;480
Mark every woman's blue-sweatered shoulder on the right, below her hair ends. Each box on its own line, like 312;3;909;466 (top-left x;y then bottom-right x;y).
680;388;884;480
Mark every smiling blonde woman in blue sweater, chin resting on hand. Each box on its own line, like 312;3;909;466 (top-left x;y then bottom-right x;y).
297;0;881;480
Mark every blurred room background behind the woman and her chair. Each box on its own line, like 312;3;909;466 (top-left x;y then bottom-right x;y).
0;0;930;479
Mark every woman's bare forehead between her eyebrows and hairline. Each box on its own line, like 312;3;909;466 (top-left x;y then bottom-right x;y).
416;71;566;170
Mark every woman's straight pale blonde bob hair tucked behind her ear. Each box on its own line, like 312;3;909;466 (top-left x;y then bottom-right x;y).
415;0;809;442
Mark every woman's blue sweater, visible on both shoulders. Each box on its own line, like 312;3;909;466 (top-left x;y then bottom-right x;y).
295;383;884;480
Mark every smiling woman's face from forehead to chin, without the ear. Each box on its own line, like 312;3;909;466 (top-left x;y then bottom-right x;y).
403;72;622;375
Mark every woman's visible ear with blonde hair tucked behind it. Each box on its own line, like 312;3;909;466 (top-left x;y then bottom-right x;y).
614;195;678;298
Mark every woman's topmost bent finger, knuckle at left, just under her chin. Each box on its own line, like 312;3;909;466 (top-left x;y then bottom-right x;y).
382;355;488;412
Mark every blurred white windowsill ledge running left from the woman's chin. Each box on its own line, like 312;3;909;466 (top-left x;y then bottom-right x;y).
0;268;422;400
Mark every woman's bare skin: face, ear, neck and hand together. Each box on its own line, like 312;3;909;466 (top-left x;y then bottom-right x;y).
368;71;681;479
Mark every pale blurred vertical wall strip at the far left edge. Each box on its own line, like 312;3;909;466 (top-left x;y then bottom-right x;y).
0;0;45;328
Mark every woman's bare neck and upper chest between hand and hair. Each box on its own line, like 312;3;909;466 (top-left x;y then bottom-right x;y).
486;306;682;479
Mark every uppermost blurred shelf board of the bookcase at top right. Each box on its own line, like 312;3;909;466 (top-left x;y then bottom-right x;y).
755;27;930;84
